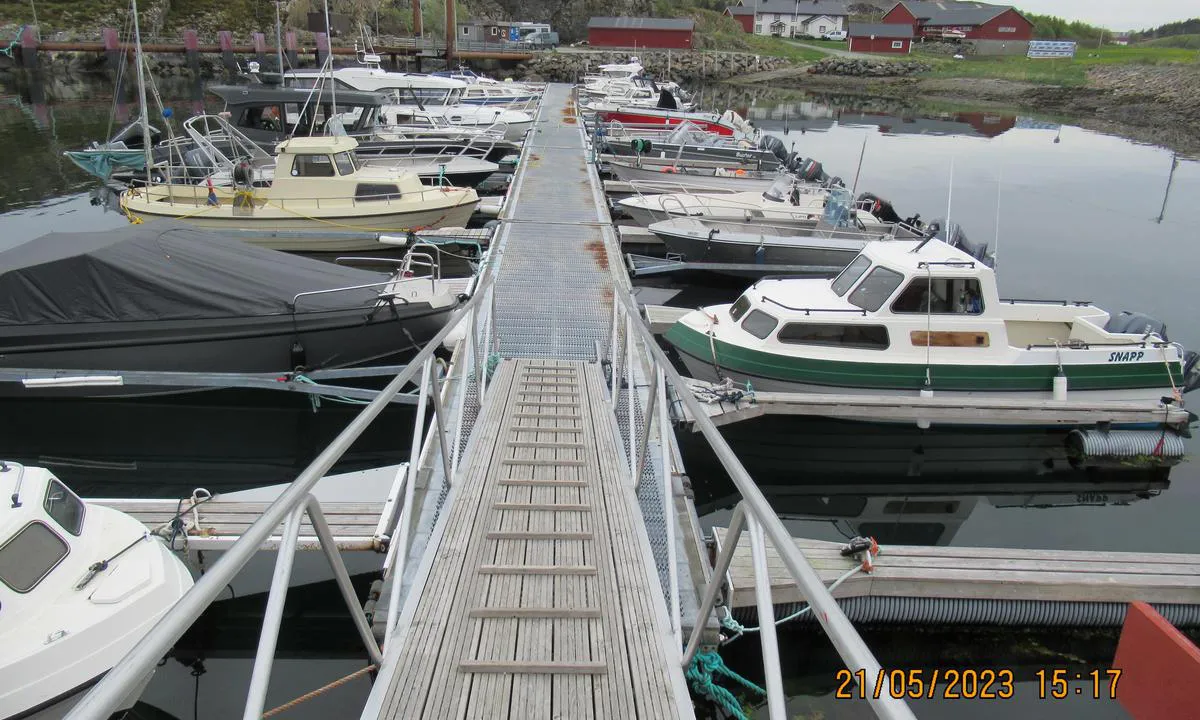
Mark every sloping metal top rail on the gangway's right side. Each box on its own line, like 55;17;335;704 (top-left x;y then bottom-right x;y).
613;283;916;720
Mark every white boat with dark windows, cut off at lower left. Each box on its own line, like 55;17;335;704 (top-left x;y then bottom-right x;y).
0;461;192;720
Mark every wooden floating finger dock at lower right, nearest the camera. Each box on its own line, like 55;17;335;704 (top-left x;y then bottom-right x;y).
713;528;1200;607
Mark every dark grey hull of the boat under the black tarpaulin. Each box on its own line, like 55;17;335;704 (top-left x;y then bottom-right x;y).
0;304;455;397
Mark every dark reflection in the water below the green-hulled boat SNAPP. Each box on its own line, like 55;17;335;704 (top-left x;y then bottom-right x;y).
678;416;1170;545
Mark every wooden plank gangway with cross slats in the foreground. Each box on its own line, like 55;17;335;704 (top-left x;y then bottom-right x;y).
379;360;694;720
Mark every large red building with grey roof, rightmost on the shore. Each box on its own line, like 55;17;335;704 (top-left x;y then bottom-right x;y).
883;0;1033;43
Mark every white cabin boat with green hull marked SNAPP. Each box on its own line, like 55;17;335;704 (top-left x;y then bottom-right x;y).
666;239;1200;420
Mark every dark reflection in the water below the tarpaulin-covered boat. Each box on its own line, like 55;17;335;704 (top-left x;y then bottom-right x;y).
0;390;414;498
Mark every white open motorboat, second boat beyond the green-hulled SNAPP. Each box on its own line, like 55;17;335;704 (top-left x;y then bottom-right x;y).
617;174;854;229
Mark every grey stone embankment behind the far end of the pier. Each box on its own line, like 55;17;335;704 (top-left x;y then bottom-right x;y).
513;50;790;83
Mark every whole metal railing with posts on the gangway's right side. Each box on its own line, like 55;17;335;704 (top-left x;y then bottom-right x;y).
598;274;914;720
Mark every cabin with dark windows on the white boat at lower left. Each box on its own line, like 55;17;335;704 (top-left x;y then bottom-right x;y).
0;461;87;614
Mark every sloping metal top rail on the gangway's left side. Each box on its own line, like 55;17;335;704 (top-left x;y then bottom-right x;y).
66;262;494;720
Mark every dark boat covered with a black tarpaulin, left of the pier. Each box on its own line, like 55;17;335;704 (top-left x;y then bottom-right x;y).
0;223;462;397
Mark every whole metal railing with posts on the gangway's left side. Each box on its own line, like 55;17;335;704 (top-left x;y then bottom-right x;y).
67;246;496;720
